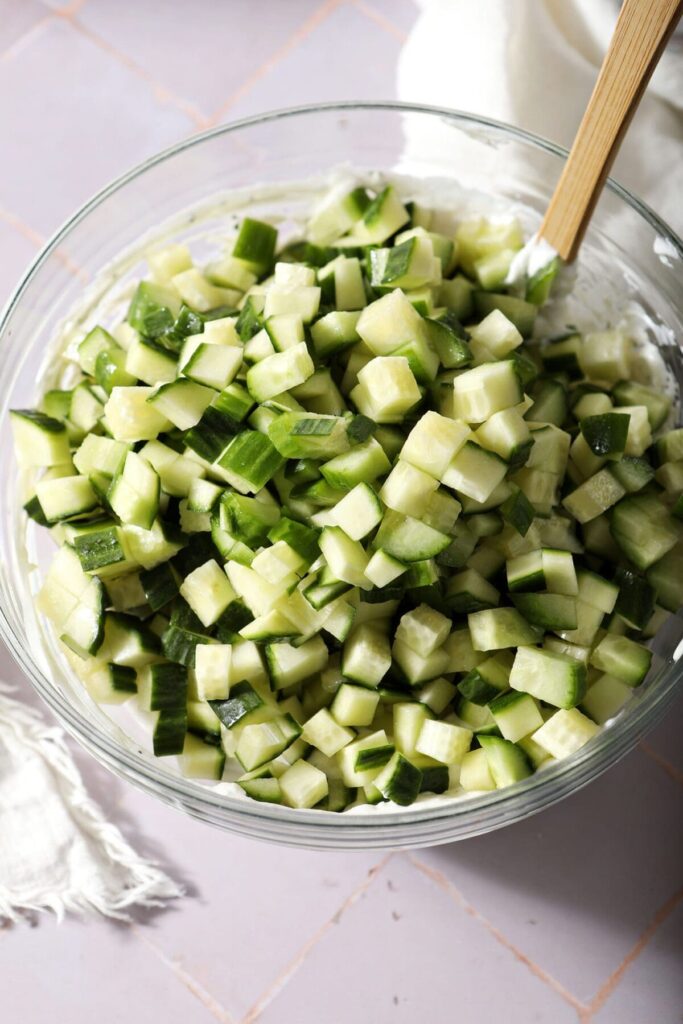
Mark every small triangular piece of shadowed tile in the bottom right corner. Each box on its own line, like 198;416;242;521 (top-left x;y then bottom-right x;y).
594;903;683;1024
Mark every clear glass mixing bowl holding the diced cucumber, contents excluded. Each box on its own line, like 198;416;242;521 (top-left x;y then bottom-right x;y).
0;103;683;849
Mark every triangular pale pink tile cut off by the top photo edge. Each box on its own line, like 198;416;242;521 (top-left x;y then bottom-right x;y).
78;0;323;116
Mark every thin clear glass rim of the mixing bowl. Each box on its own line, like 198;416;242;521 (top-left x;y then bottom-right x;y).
0;100;683;847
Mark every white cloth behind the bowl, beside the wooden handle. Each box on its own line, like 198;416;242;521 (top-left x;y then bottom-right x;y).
398;0;683;233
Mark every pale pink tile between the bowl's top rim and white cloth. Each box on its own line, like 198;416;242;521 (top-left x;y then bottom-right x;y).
223;4;400;120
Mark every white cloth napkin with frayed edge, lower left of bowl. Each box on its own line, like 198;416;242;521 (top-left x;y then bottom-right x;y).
0;683;182;922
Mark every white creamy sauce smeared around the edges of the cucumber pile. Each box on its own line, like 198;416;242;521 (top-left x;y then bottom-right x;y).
20;166;678;816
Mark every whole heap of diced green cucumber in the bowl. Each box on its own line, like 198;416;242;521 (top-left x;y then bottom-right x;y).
17;178;683;812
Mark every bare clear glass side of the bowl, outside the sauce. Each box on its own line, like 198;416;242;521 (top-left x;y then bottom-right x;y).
0;103;683;848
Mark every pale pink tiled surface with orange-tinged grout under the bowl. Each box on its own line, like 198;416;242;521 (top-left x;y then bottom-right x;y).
0;0;683;1024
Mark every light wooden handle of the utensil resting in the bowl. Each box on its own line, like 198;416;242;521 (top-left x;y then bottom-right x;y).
539;0;683;262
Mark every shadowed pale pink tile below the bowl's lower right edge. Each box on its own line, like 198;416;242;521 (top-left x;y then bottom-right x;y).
417;752;683;1001
